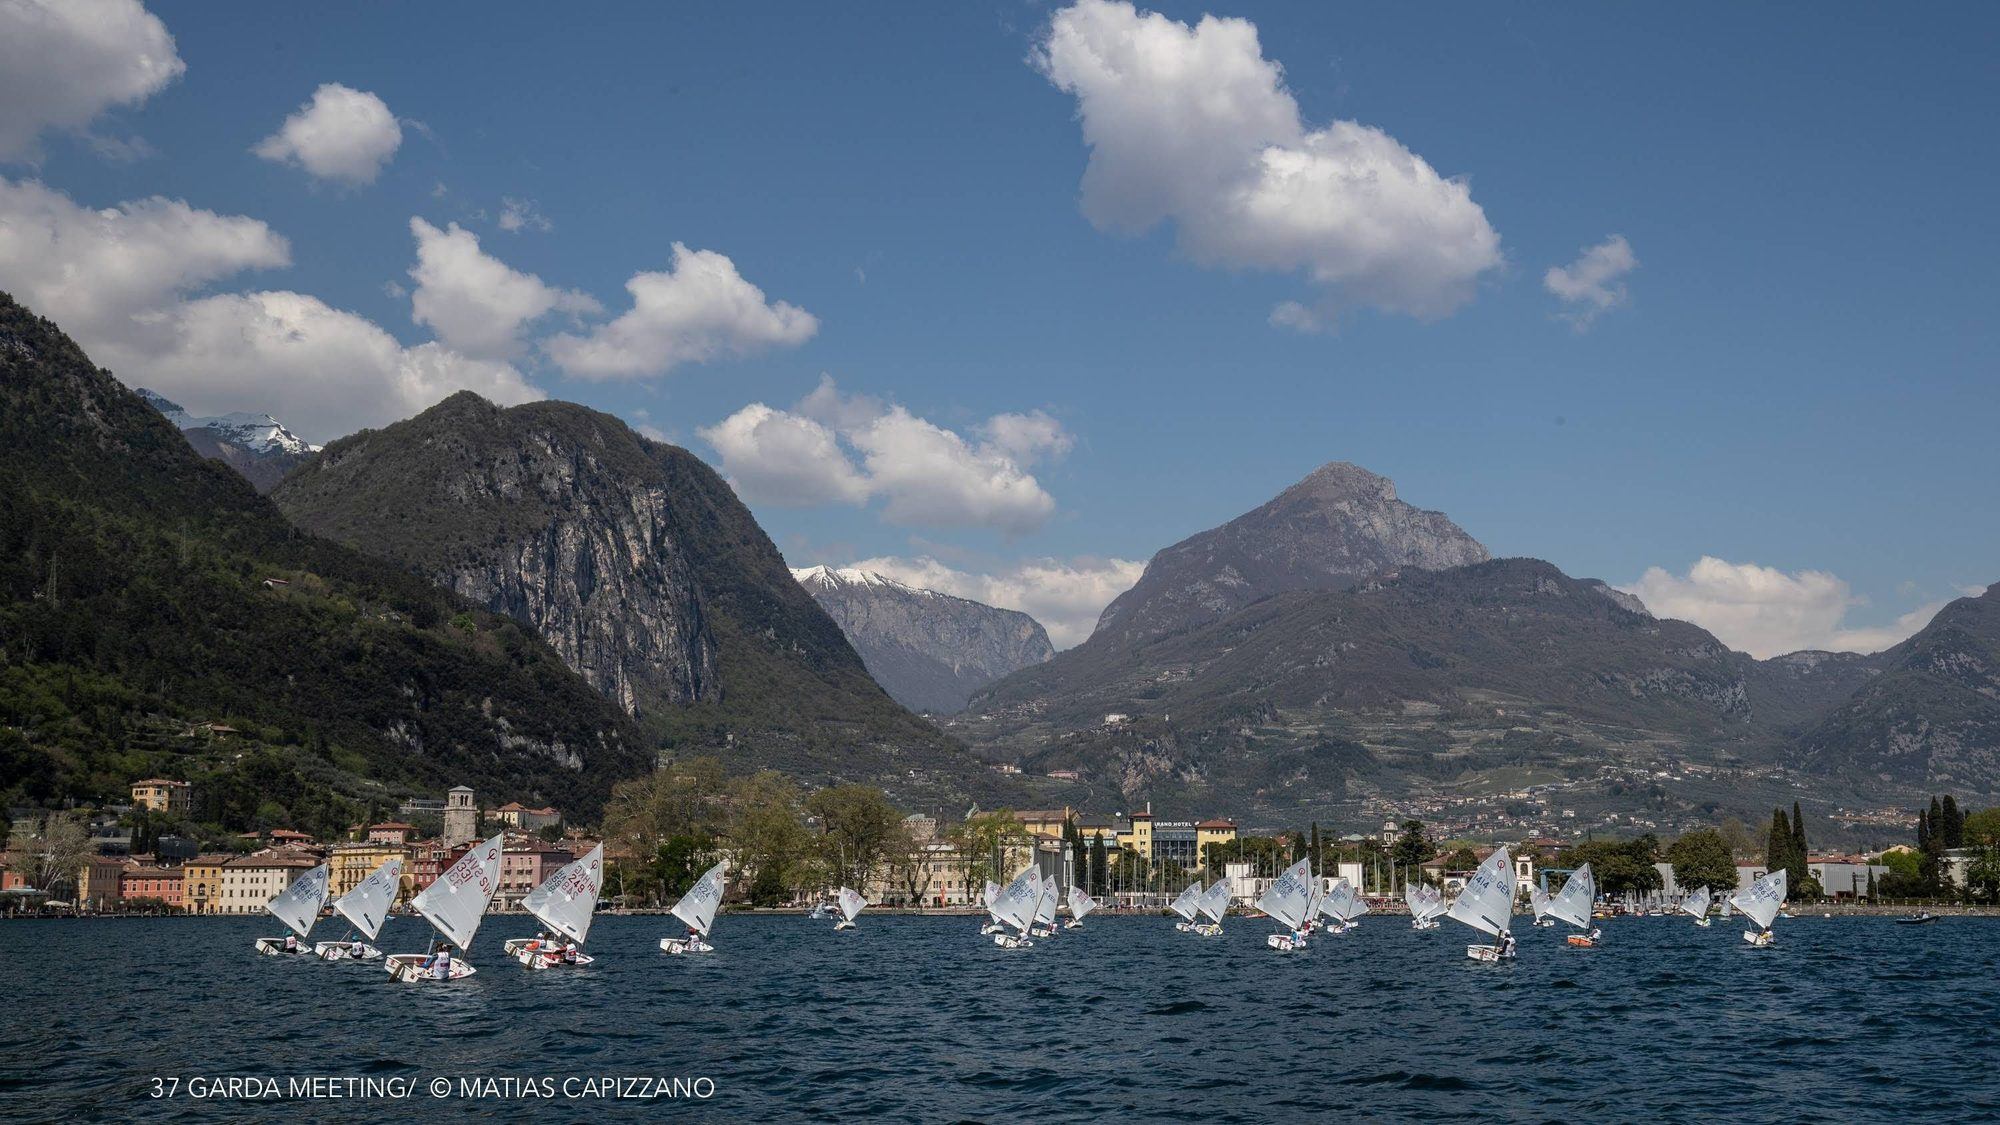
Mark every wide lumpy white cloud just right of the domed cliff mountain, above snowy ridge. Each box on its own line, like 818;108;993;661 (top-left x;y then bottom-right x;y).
698;378;1072;534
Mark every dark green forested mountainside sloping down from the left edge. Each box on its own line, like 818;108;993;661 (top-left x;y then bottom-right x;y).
0;294;652;833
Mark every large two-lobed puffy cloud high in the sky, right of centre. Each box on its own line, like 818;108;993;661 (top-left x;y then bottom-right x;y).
1034;0;1502;318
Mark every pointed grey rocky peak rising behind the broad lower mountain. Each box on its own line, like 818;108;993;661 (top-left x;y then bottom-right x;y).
1090;460;1490;645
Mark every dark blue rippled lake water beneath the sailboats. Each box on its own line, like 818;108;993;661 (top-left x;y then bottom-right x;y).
0;915;2000;1121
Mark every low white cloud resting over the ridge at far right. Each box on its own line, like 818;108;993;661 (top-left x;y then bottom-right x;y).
1618;554;1944;659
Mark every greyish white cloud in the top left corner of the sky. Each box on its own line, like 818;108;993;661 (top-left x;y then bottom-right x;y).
0;0;188;160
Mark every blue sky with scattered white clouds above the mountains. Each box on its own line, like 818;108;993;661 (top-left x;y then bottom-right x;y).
0;0;2000;657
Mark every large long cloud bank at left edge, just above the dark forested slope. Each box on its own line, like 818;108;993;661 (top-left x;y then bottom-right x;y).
0;178;540;440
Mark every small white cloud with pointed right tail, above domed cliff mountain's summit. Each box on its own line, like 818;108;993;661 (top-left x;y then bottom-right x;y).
410;218;600;358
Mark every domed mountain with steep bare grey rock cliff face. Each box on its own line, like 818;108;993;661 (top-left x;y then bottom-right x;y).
272;392;996;803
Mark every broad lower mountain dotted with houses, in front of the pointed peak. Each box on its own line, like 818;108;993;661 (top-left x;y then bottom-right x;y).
954;558;1876;823
